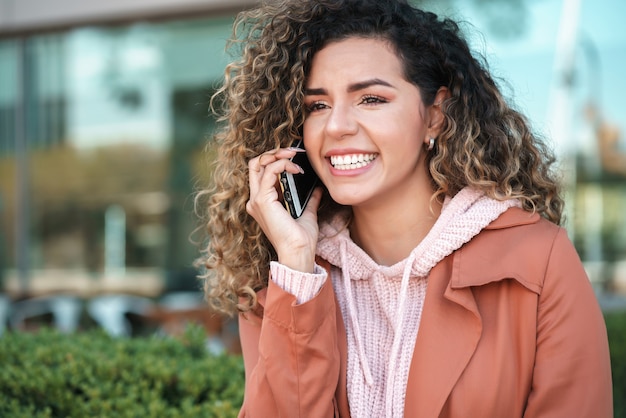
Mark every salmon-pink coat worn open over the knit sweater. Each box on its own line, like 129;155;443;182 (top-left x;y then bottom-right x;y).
239;208;613;418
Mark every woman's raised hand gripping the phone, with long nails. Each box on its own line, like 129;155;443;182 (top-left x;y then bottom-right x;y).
246;148;322;273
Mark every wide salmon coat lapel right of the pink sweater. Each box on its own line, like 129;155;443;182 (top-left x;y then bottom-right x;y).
404;254;482;418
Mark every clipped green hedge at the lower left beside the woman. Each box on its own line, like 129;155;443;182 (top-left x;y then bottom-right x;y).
0;327;244;418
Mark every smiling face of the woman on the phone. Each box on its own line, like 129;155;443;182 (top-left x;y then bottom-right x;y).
304;37;435;211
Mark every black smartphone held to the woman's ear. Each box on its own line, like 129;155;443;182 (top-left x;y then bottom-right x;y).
279;140;320;219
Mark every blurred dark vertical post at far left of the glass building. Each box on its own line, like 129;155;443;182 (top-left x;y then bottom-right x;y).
15;38;31;295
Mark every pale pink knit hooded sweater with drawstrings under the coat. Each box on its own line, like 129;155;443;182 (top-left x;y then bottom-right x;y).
271;188;519;418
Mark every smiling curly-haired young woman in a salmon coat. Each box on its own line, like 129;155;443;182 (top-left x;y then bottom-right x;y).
195;0;612;418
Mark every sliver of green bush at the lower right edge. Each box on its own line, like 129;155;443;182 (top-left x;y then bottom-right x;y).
604;312;626;418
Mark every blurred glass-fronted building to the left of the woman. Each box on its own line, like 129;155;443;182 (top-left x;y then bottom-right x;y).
0;0;252;296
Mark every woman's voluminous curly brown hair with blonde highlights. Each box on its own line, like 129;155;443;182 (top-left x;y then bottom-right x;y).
196;0;563;314
